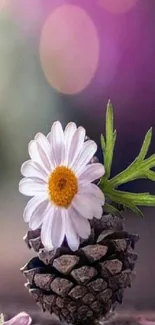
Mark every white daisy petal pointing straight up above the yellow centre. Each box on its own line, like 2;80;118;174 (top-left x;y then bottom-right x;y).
50;121;64;165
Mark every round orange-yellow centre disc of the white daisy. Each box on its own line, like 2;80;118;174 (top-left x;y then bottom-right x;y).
48;166;78;208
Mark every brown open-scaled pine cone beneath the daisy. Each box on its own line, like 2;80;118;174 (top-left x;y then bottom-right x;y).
21;215;139;325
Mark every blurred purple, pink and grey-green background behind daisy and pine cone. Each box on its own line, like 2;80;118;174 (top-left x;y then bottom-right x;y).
0;0;155;309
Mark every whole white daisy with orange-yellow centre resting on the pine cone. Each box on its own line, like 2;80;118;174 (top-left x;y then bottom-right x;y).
19;121;105;251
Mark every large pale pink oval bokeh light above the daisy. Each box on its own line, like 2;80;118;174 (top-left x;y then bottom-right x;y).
40;5;99;95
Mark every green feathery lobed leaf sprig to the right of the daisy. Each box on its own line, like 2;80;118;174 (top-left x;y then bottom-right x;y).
99;101;155;215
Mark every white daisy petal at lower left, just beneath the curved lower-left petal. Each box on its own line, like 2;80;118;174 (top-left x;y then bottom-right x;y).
29;200;51;230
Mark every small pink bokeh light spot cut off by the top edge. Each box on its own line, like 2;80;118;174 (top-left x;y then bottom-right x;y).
98;0;138;14
